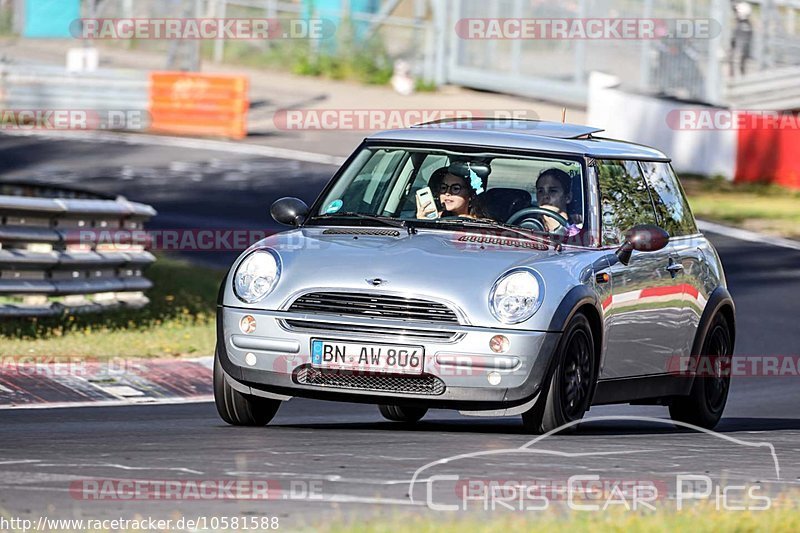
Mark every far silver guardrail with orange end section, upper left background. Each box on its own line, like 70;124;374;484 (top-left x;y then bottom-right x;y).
0;64;250;139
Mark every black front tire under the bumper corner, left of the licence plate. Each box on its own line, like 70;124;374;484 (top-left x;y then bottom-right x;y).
214;356;281;426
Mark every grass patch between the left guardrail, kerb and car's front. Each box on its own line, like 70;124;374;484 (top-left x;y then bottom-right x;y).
0;256;224;358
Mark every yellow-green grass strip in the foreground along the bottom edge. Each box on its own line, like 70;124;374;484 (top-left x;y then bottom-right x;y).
318;502;800;533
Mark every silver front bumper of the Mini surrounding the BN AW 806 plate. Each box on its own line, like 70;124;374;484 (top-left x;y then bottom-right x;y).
217;306;560;410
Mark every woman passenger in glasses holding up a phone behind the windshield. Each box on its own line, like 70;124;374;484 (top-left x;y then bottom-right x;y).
417;165;489;219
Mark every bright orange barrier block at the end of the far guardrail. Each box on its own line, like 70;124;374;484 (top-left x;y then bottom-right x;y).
150;72;250;139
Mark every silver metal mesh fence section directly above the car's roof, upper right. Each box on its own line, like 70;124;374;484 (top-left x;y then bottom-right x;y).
448;0;727;105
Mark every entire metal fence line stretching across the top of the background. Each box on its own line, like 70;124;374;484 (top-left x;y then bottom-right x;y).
6;0;800;105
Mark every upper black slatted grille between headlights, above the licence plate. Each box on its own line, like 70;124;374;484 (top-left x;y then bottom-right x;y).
289;292;459;324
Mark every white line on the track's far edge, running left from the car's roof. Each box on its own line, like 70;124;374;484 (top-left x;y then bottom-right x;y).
4;130;345;166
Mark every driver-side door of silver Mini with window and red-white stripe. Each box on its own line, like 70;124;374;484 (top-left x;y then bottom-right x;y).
597;160;683;379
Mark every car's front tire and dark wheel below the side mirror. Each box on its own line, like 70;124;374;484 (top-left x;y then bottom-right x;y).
522;313;597;434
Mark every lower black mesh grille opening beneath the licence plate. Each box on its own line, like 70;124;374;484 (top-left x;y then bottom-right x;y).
294;365;445;396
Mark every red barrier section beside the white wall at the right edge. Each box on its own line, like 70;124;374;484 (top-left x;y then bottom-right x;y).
735;111;800;189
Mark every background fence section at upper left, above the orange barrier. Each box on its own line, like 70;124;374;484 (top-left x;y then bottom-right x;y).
83;0;438;83
